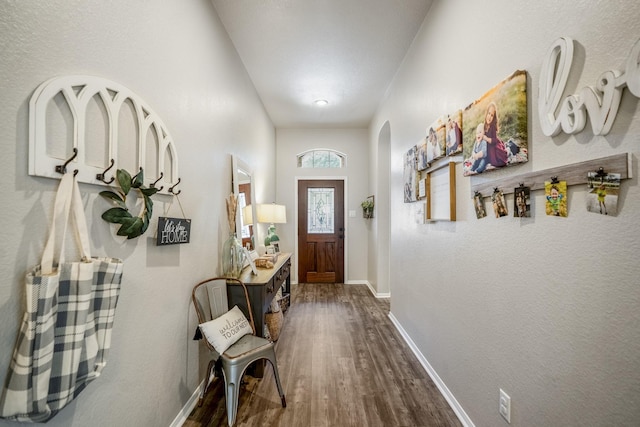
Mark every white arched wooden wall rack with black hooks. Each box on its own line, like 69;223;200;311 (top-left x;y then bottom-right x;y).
29;75;180;194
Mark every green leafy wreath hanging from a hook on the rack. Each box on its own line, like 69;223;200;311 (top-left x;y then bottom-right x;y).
100;168;158;239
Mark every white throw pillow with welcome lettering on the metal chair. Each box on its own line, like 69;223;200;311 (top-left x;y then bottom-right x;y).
199;305;253;354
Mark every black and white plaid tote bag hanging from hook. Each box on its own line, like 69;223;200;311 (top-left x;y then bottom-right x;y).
0;173;122;422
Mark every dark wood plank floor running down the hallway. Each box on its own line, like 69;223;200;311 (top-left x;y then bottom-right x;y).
183;284;461;427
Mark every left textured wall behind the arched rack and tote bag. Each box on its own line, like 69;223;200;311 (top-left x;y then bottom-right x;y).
0;0;275;427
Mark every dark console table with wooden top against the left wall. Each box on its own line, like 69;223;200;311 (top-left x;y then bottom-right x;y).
227;252;291;376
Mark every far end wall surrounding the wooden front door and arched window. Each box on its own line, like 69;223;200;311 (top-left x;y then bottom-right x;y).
276;129;371;283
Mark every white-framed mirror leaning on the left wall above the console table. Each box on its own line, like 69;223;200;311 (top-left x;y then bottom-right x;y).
231;156;258;250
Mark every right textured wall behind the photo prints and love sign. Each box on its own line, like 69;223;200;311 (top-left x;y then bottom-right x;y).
370;0;640;426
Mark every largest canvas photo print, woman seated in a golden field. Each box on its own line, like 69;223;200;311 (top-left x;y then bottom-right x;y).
462;70;529;176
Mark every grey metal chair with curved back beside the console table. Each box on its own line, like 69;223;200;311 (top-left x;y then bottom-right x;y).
191;277;287;426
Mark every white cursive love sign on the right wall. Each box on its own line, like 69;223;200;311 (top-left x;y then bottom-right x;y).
538;37;640;136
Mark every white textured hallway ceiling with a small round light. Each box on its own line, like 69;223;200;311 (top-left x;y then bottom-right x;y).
212;0;432;128
